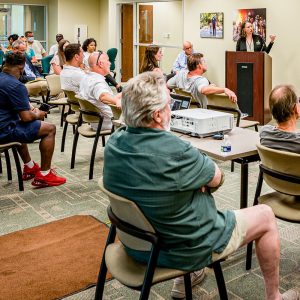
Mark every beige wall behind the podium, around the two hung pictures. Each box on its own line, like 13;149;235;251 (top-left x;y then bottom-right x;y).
184;0;300;91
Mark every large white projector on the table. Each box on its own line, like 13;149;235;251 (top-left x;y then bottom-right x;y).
171;108;234;137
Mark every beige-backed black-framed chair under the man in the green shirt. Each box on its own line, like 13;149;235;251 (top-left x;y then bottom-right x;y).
95;179;228;300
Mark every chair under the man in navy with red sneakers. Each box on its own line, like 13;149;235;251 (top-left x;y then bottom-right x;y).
0;142;24;191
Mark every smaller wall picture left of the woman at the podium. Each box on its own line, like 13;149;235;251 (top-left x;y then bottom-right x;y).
200;13;224;39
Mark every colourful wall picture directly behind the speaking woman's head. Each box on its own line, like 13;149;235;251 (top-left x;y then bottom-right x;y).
232;8;267;41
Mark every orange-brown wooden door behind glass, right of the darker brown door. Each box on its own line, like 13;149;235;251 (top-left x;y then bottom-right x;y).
139;5;153;70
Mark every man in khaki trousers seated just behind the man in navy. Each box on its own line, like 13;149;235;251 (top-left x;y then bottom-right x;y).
12;40;48;96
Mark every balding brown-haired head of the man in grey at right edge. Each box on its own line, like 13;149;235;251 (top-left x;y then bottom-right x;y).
269;85;298;123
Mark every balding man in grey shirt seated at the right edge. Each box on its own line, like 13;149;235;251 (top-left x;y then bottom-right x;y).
260;85;300;154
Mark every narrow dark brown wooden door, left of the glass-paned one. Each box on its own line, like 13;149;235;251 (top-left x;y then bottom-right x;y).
121;4;133;82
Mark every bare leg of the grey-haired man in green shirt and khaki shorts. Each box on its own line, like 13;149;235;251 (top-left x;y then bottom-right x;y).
240;205;281;300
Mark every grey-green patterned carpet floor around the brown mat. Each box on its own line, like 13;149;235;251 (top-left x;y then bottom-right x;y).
0;110;300;300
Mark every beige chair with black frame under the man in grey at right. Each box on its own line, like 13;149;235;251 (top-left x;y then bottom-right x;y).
246;145;300;270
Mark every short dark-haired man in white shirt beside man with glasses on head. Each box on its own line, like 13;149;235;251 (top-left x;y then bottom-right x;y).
60;43;85;94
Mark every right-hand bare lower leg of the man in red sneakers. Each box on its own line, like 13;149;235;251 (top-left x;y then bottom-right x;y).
39;122;56;171
